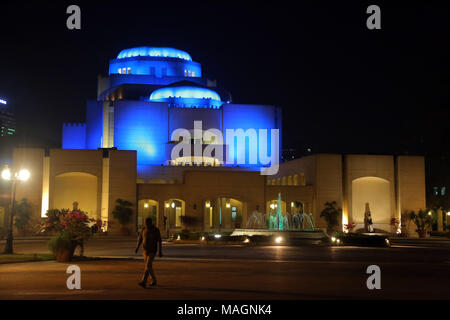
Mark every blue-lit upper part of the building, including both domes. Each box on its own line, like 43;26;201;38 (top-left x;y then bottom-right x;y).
62;47;281;177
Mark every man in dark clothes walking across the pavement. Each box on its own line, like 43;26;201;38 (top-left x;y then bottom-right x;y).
135;218;162;288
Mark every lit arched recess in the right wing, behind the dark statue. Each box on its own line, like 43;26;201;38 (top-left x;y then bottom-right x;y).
351;177;392;228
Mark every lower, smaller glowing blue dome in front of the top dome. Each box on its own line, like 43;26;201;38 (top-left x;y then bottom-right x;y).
150;86;220;101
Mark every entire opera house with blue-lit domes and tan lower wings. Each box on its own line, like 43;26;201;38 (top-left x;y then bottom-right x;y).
10;47;425;233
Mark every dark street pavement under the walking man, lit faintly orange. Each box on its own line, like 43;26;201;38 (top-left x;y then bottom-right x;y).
0;238;450;300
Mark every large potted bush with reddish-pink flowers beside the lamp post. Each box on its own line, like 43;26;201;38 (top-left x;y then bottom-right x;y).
41;209;95;262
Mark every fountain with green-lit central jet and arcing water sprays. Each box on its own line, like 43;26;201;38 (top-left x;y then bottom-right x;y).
231;193;326;242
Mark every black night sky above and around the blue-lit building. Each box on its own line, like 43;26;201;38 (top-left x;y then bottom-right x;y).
0;1;450;154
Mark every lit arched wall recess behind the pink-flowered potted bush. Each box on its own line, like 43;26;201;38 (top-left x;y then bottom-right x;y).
52;172;98;218
